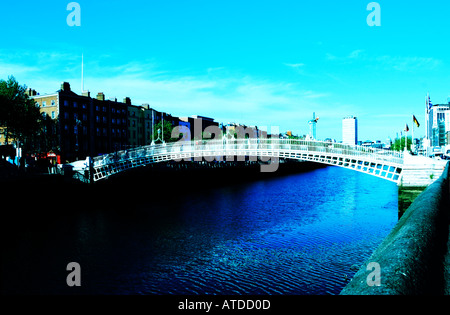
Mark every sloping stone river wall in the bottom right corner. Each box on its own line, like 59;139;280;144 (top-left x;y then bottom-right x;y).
341;163;450;295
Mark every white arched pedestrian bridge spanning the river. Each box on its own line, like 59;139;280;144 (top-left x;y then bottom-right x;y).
82;138;414;183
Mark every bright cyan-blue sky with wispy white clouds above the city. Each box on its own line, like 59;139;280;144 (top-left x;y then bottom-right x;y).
0;0;450;141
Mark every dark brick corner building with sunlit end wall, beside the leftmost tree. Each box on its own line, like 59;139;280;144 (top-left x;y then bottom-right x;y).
28;82;128;161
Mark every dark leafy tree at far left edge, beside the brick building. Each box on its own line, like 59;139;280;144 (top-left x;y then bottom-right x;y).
0;76;41;149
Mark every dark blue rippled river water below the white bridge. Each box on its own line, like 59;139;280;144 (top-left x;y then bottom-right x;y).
1;166;398;295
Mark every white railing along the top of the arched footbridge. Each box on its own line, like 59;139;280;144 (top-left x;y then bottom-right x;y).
93;138;403;167
